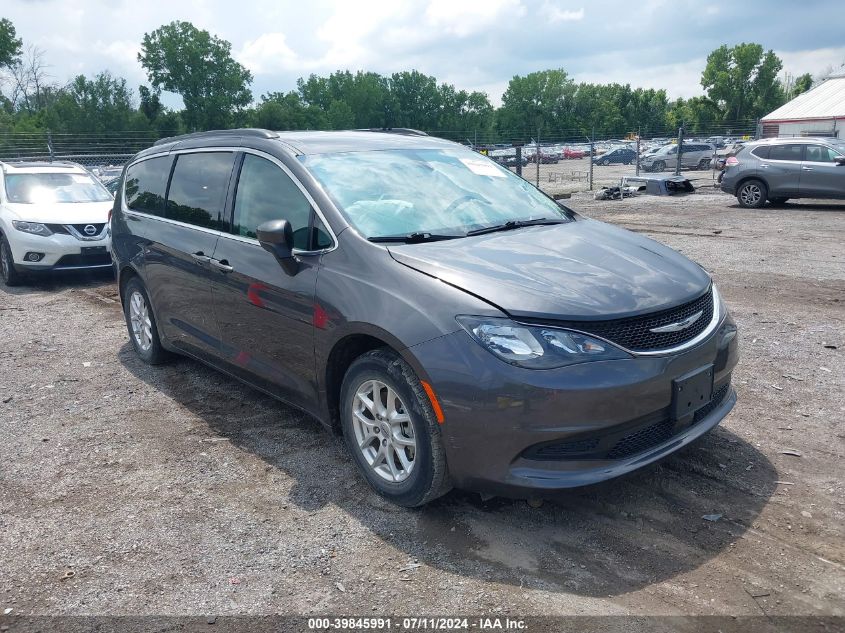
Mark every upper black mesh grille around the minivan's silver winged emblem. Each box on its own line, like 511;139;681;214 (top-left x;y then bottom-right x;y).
556;286;713;352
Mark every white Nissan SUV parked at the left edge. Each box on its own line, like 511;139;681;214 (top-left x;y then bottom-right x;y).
0;162;114;286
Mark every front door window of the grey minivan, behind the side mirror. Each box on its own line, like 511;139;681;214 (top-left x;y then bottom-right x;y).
232;154;311;250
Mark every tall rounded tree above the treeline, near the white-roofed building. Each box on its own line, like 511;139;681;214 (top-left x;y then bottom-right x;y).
701;43;785;122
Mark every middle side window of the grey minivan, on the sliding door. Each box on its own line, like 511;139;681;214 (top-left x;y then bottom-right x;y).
166;152;235;229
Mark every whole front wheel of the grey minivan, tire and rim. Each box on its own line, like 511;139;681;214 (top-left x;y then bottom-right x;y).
340;349;452;508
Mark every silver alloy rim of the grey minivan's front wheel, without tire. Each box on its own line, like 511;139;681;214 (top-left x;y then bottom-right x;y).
352;380;417;483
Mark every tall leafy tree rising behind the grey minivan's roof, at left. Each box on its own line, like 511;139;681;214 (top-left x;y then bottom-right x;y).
138;22;252;130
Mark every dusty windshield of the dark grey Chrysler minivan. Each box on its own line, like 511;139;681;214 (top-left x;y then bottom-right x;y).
303;149;570;238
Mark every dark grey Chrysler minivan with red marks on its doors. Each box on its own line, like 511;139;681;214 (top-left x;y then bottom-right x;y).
112;130;737;506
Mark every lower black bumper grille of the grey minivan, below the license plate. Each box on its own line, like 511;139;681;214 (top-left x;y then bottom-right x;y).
522;379;731;461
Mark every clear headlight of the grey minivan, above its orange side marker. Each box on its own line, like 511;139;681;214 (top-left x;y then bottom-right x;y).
457;316;632;369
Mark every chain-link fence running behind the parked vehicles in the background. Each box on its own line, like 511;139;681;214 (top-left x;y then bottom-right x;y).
0;121;760;195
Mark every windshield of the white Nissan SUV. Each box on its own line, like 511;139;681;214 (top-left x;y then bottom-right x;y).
5;172;112;204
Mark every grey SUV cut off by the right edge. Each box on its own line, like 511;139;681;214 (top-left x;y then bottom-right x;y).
720;138;845;208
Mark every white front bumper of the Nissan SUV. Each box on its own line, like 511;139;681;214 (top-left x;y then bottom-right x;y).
8;231;111;272
